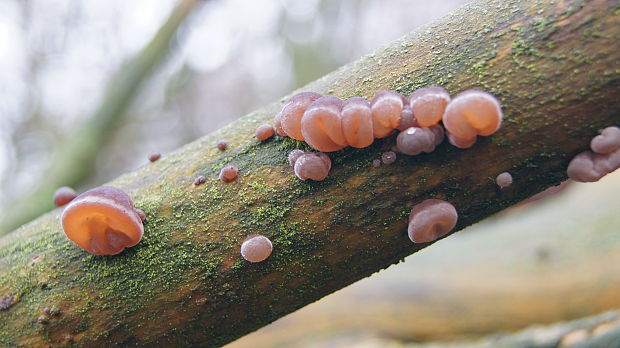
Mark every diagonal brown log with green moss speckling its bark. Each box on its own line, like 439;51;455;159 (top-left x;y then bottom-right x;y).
0;0;620;347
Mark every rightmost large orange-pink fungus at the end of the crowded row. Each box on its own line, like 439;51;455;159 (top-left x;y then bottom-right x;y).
443;90;503;143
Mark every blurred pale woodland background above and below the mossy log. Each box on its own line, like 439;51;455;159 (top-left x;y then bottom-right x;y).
0;0;620;347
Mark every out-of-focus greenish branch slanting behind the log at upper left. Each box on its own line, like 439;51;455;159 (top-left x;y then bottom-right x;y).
0;0;199;235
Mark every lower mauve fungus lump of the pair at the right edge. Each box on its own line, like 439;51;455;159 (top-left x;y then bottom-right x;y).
566;149;620;182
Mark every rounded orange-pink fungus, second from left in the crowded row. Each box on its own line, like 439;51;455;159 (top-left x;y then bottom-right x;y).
302;96;348;152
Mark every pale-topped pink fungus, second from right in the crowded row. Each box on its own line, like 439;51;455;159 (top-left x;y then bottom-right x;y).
409;87;450;127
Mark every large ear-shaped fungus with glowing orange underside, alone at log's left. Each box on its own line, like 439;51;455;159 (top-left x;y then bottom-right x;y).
61;186;144;255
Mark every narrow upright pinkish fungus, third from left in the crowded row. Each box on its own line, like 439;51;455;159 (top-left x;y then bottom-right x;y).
342;97;375;148
